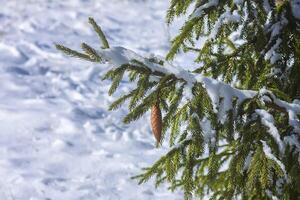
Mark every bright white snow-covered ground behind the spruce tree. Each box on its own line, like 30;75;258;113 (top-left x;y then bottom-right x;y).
0;0;183;200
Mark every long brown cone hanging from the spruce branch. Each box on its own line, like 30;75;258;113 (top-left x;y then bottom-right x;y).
151;103;162;143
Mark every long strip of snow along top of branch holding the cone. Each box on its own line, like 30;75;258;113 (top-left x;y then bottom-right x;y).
97;47;300;119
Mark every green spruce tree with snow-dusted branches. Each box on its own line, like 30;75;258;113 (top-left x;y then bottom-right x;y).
56;0;300;200
